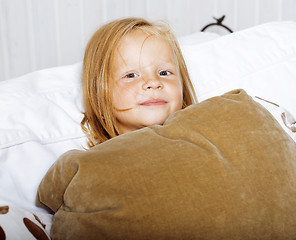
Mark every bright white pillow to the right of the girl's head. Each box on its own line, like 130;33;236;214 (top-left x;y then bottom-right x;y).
182;22;296;116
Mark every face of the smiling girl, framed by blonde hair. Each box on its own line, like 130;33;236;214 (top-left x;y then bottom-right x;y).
112;30;183;134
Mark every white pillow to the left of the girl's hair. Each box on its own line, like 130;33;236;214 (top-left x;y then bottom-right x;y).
0;63;86;211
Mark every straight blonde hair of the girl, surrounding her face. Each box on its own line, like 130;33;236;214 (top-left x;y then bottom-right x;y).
81;18;196;147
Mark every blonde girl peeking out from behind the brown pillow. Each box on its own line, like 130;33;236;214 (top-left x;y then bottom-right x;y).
81;18;196;147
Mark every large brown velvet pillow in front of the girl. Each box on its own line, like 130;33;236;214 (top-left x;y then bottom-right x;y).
38;90;296;240
